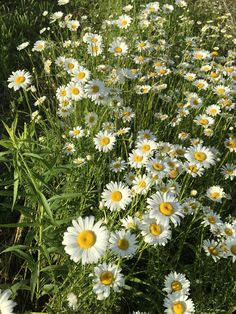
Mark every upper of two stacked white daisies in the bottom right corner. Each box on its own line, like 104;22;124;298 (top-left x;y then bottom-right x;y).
163;272;190;295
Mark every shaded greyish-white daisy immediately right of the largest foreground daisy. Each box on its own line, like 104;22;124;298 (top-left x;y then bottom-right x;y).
109;230;137;257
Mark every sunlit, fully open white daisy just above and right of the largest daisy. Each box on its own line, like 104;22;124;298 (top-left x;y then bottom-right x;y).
102;182;132;211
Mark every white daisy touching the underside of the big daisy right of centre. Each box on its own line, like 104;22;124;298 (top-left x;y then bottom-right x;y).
138;215;171;246
